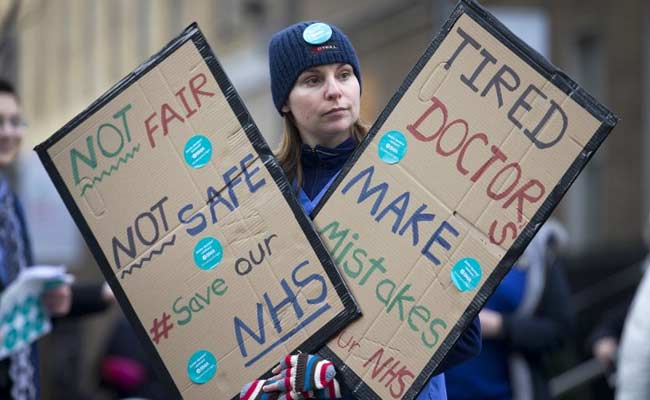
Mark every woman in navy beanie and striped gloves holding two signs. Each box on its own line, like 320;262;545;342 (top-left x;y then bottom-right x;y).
241;21;481;400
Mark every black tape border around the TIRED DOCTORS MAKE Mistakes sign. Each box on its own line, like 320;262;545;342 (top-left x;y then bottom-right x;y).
312;0;618;400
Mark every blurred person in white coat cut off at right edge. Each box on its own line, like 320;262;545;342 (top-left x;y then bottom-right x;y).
616;211;650;400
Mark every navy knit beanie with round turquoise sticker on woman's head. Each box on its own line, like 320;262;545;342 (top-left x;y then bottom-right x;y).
269;21;361;115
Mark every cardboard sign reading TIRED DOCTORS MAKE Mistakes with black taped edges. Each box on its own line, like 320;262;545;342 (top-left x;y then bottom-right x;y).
314;1;617;399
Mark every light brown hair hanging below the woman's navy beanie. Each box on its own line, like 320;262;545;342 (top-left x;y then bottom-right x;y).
276;113;369;188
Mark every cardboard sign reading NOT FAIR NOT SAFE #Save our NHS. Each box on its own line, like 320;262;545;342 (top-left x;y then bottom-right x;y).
36;25;359;399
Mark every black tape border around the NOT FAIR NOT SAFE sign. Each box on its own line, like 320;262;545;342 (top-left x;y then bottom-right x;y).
34;22;361;399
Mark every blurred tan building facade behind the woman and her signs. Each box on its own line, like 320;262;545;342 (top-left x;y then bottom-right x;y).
0;0;650;398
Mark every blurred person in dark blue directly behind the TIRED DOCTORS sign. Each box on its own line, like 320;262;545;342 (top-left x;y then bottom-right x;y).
446;220;574;400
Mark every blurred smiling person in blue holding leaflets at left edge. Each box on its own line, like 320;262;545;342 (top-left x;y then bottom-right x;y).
0;79;113;400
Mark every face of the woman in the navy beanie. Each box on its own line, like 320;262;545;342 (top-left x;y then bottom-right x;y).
282;64;361;147
